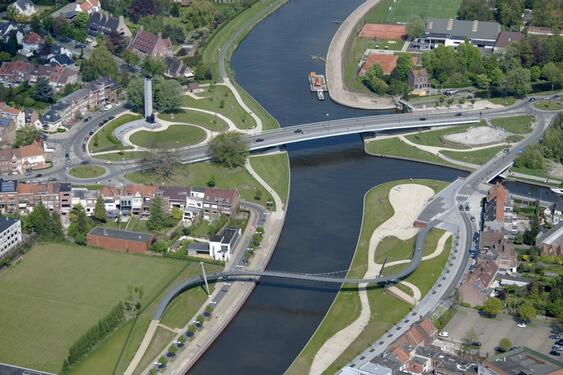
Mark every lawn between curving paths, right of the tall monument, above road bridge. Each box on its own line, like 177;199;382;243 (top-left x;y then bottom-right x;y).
182;85;256;129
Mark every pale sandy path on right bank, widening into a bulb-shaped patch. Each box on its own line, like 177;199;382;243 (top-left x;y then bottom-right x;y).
309;184;434;375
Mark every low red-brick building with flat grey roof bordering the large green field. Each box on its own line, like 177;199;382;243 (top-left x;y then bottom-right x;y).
86;227;155;254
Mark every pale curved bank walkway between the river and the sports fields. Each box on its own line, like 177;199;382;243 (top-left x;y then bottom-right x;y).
326;0;396;109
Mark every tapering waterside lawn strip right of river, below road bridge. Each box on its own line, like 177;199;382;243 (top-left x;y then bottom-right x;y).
366;137;457;168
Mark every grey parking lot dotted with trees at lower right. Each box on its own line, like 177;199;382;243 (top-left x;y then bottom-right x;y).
444;307;561;360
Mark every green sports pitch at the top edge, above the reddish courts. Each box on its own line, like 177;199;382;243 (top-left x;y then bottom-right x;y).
365;0;461;23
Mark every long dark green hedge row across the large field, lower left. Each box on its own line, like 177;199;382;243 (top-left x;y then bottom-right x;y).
62;302;124;373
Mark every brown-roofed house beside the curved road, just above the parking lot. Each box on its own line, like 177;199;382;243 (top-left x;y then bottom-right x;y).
459;259;498;306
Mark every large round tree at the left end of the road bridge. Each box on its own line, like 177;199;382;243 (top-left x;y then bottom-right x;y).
209;131;249;168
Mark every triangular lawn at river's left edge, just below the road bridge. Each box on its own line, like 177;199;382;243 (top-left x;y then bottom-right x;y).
249;152;289;206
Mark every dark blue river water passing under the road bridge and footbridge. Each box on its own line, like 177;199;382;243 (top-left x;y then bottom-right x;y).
190;0;549;375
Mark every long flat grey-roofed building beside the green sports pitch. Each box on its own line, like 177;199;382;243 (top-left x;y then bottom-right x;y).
416;18;500;51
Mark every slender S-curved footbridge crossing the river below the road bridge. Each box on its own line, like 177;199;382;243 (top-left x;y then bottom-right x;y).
152;220;440;321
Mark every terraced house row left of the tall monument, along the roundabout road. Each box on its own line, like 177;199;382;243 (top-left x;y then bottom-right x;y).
41;77;119;131
